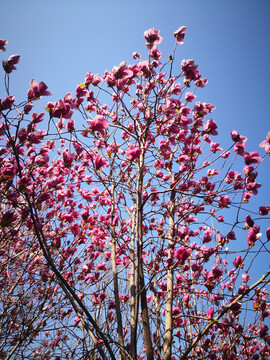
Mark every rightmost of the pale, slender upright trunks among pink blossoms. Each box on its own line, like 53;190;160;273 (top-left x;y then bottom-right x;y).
163;190;175;360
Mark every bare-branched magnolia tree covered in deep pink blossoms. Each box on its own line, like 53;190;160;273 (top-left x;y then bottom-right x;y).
0;26;270;360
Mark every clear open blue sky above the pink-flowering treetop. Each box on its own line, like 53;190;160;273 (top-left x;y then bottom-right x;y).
0;0;270;268
